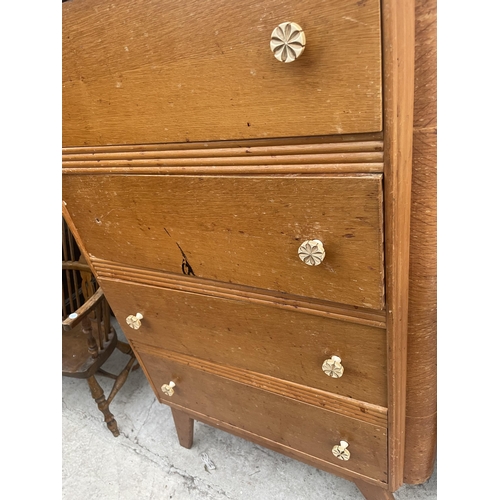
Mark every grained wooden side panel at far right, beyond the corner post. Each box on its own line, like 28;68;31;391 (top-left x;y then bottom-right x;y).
404;0;437;484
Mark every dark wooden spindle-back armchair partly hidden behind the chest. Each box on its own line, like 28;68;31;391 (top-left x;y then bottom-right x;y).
62;219;138;437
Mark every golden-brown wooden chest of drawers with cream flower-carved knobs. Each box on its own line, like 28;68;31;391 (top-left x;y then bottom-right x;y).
63;0;435;500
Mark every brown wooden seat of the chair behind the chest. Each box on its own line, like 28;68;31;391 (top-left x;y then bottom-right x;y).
62;324;117;378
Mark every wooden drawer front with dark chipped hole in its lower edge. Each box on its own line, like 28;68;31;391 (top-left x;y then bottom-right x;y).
63;174;384;309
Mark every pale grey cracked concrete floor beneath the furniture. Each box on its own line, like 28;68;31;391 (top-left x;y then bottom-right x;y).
62;323;437;500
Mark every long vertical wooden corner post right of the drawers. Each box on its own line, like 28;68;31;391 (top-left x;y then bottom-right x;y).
382;0;415;491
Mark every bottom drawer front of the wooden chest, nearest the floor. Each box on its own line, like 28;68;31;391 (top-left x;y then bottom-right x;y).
138;349;387;482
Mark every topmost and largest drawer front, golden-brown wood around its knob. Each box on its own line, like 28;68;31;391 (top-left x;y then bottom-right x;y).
63;0;382;146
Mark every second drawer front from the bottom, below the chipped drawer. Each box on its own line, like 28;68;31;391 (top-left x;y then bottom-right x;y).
101;279;387;407
